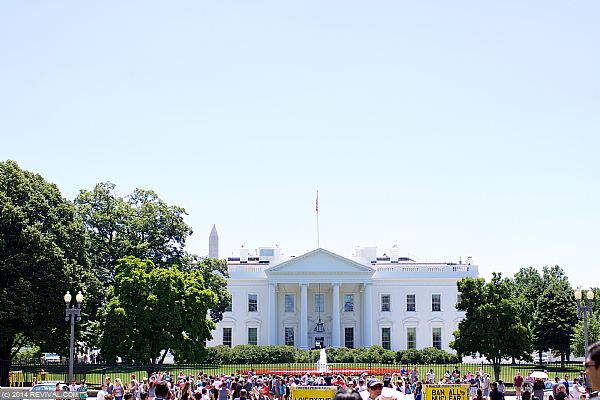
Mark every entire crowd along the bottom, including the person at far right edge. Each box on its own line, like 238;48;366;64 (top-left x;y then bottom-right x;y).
47;342;600;400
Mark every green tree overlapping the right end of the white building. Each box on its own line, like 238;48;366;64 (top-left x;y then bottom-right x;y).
450;273;532;380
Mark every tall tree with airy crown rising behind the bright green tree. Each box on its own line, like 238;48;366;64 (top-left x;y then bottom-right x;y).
75;182;192;282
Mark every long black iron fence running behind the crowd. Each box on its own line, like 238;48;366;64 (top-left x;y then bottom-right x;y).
0;360;582;387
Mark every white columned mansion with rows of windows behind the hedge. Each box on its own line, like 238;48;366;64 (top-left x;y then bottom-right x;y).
207;248;478;351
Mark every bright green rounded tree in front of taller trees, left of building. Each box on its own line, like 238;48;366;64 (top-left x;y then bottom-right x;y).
100;257;217;365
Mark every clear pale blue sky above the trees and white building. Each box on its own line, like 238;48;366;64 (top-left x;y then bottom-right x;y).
0;0;600;286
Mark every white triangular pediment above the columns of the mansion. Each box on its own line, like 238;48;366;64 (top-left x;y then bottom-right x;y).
265;248;375;275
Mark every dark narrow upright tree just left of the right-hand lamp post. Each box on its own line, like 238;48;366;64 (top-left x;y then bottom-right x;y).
533;266;577;363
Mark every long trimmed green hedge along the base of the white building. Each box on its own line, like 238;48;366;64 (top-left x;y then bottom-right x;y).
207;345;460;364
